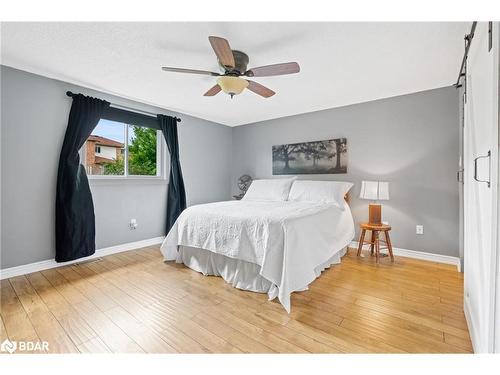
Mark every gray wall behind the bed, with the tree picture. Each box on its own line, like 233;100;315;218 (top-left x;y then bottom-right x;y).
232;87;459;257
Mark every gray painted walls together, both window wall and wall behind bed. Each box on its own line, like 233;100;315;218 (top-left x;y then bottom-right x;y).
0;66;459;268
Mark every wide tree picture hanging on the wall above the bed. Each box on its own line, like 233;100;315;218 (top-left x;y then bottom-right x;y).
273;138;347;175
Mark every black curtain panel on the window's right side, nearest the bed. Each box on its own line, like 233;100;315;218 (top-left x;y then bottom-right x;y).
158;115;186;234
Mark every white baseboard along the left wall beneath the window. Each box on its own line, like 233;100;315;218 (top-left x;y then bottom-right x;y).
0;236;165;280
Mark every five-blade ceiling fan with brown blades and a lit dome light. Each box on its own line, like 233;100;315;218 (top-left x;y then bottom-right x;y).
162;36;300;98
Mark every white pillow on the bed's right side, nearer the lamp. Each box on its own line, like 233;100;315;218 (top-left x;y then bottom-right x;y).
288;180;354;209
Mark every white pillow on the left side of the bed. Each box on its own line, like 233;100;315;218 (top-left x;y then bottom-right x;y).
242;177;296;201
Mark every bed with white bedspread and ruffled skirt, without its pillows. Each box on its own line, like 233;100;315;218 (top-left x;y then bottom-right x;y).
161;181;354;312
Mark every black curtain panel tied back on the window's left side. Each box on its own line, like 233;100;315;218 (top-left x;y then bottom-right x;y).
56;94;110;262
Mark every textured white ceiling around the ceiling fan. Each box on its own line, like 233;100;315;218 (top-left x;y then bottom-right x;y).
1;22;470;126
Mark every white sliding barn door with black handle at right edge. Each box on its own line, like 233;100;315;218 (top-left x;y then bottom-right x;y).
464;22;499;352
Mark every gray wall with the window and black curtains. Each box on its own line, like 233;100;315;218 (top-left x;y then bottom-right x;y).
0;66;232;268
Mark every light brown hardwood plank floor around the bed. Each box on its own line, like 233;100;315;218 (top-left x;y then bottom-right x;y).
0;247;472;353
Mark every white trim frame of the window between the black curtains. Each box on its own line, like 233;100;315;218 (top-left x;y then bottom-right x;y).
79;122;167;185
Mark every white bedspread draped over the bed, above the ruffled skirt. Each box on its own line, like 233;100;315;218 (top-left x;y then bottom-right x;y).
161;201;354;312
